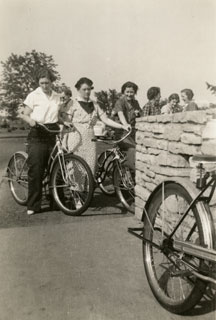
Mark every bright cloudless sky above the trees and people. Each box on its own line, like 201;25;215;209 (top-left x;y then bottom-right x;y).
0;0;216;103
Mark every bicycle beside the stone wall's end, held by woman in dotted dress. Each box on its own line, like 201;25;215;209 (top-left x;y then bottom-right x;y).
92;129;135;212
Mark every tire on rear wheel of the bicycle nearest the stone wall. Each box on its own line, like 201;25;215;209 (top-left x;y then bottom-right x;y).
97;150;115;197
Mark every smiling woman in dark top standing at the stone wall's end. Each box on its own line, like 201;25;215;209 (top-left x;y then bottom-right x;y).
113;81;142;170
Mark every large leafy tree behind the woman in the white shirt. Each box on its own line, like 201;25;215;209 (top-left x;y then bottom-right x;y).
0;50;63;120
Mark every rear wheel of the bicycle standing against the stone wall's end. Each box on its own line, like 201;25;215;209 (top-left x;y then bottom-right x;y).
97;150;115;196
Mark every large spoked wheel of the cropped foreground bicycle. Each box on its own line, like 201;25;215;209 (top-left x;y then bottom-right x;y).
143;182;210;314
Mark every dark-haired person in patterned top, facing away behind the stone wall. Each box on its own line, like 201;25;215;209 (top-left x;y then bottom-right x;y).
143;87;161;117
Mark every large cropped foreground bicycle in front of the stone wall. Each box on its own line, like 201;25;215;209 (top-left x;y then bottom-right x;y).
128;155;216;314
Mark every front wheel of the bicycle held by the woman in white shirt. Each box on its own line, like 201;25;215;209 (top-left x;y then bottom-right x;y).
50;154;94;216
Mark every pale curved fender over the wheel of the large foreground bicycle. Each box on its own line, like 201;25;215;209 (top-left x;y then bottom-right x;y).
141;177;214;248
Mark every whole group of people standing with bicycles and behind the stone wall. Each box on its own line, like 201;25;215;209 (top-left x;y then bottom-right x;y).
23;69;197;215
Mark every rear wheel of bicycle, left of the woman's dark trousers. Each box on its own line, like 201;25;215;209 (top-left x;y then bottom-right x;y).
7;152;28;206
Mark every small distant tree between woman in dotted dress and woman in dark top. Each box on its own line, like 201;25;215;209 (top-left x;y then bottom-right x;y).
95;89;121;116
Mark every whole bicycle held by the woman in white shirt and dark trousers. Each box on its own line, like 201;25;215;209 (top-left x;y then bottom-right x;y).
7;124;94;216
